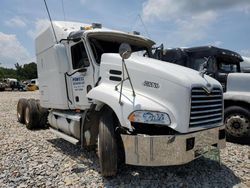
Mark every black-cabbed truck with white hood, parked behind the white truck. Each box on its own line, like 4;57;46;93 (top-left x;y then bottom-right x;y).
156;46;250;139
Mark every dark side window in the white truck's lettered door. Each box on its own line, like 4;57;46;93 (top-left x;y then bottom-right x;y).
71;42;89;69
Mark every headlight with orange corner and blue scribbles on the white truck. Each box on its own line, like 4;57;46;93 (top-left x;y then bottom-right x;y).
128;111;171;125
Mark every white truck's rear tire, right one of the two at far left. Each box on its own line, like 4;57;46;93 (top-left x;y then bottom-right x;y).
24;99;39;130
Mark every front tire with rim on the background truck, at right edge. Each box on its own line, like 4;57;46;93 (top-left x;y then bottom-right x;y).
224;106;250;139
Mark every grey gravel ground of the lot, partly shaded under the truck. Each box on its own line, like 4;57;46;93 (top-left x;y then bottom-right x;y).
0;91;250;188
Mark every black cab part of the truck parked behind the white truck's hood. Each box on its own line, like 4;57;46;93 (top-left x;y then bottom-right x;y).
156;46;243;92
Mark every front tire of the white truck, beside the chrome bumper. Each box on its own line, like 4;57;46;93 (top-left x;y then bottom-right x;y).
98;112;118;177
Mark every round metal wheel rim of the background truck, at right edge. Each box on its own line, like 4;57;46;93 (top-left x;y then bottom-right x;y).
225;114;250;137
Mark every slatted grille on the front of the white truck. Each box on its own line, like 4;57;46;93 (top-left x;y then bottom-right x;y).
189;87;223;127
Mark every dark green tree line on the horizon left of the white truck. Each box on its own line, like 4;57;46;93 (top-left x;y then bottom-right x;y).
0;62;37;80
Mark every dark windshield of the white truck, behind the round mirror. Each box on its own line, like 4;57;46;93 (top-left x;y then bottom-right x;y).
89;35;152;64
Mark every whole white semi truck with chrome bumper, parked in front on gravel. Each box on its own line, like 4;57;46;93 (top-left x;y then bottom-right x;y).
17;21;225;176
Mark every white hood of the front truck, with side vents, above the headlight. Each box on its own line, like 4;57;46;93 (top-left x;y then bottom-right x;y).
97;54;222;133
